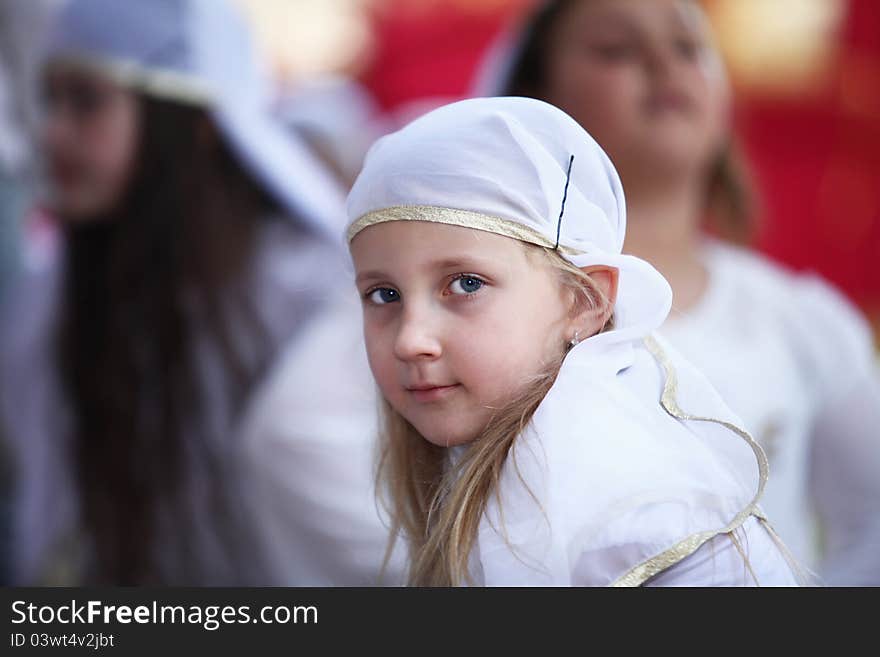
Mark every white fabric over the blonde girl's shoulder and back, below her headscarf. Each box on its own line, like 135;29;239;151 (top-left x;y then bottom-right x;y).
477;338;797;586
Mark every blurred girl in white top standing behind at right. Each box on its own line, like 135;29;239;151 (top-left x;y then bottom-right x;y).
480;0;880;585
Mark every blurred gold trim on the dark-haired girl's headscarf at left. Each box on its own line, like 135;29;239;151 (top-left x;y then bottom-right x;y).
54;53;214;106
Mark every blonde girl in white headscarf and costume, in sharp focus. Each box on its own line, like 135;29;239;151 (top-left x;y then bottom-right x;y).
348;93;795;585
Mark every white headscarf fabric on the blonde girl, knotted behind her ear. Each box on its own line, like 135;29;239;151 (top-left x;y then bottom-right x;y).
348;98;672;340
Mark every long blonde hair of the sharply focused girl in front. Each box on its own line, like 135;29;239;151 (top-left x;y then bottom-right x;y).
378;245;613;586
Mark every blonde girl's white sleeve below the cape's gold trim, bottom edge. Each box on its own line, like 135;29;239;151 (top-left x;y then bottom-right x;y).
646;517;798;587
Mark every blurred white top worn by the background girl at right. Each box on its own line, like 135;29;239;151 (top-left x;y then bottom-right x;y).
662;242;880;586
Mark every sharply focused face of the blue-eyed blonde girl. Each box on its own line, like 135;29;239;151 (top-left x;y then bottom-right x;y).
351;221;599;446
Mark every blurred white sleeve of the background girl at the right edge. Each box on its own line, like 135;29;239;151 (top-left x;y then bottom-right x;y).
798;279;880;586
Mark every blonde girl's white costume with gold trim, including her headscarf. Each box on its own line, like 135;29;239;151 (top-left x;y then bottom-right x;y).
348;98;796;585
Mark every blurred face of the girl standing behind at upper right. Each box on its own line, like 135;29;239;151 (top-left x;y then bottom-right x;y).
544;0;728;183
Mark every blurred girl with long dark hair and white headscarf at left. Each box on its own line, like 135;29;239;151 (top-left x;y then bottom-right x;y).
0;0;393;585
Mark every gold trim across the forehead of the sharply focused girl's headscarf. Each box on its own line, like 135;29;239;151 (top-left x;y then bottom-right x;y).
347;205;580;255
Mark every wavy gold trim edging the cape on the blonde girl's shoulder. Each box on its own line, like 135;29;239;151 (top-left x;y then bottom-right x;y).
611;336;770;586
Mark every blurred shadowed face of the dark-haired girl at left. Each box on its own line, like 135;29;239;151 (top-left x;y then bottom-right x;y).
43;67;140;221
